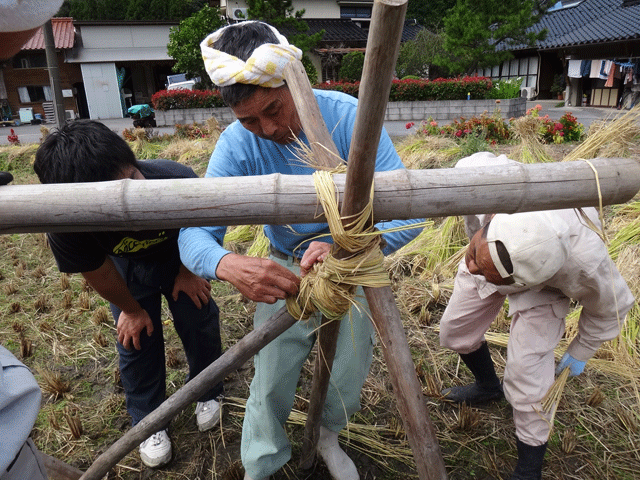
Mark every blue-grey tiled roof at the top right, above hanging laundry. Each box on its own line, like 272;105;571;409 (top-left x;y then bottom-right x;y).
520;0;640;49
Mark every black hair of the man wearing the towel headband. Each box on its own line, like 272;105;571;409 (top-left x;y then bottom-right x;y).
213;22;280;107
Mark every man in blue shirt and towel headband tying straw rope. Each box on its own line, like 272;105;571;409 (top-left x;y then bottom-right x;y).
179;22;420;480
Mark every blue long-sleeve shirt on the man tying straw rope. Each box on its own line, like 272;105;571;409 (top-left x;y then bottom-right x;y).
178;90;422;279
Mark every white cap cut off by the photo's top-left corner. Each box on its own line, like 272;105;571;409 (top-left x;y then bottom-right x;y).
0;0;63;32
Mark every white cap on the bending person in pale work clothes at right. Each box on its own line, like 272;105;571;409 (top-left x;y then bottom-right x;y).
487;212;569;286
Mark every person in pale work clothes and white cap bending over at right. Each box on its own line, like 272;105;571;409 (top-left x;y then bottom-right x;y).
440;152;635;480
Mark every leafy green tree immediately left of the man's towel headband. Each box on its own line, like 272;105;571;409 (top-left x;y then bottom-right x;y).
167;6;226;87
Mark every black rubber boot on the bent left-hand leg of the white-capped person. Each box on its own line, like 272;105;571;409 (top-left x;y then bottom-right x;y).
442;342;504;405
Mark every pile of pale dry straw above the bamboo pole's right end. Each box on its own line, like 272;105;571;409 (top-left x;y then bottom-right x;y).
563;106;640;162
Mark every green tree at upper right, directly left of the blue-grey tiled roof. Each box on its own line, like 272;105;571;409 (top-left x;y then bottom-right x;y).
435;0;547;74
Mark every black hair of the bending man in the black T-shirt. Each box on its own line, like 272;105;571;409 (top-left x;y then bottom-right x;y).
33;120;139;183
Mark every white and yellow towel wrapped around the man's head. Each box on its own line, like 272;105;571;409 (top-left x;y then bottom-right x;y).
200;22;302;88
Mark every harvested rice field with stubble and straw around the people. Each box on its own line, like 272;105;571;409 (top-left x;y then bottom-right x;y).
0;117;640;480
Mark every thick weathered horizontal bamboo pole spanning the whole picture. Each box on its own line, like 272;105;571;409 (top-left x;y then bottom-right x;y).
0;158;640;233
